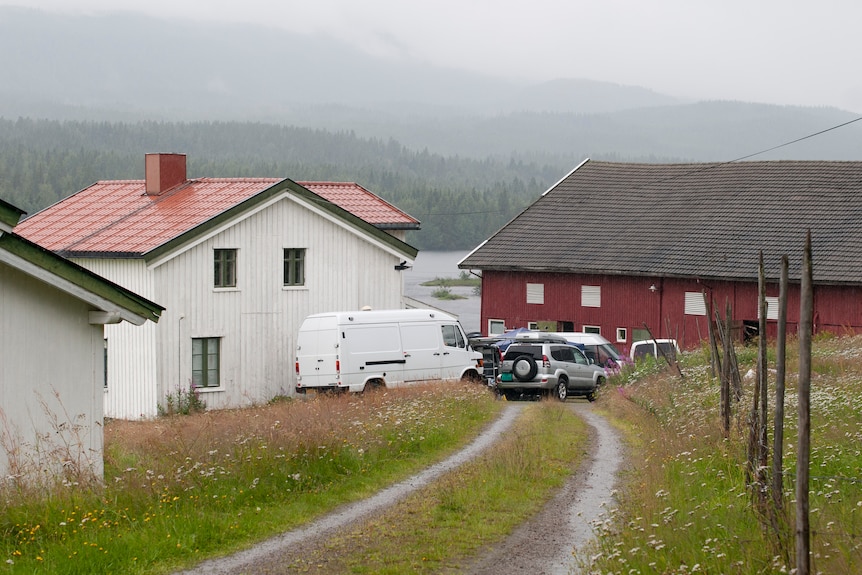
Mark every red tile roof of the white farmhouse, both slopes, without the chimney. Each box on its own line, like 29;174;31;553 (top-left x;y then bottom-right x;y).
15;178;418;255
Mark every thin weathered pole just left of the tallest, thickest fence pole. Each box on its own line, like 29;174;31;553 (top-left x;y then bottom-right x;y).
772;256;789;506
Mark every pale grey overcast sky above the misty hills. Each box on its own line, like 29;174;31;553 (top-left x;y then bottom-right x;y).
6;0;862;113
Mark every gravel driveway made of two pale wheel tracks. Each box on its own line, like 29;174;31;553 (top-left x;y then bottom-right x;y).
176;402;622;575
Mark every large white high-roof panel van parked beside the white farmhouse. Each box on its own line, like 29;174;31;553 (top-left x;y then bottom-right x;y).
296;309;482;393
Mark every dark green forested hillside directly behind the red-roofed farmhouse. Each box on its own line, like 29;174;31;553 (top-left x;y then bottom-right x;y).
0;119;560;250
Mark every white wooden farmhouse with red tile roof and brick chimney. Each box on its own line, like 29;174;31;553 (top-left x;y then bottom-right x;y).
16;154;419;419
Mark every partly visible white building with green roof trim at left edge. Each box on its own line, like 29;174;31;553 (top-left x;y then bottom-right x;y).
0;200;163;485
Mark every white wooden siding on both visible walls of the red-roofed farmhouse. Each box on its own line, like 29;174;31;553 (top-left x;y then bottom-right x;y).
76;197;403;419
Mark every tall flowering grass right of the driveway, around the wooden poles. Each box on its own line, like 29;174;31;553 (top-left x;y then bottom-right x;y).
579;337;862;575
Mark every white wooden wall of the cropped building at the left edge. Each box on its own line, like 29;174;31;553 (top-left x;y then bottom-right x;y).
0;264;104;479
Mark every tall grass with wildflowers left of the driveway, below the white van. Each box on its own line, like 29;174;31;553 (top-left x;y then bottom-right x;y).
0;384;500;574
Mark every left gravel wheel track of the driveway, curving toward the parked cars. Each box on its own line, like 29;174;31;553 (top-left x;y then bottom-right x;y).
174;403;522;575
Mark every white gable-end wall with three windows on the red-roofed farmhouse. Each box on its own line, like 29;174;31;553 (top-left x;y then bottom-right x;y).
153;200;402;414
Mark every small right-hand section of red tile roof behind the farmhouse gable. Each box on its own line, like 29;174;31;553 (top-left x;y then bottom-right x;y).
296;182;419;230
